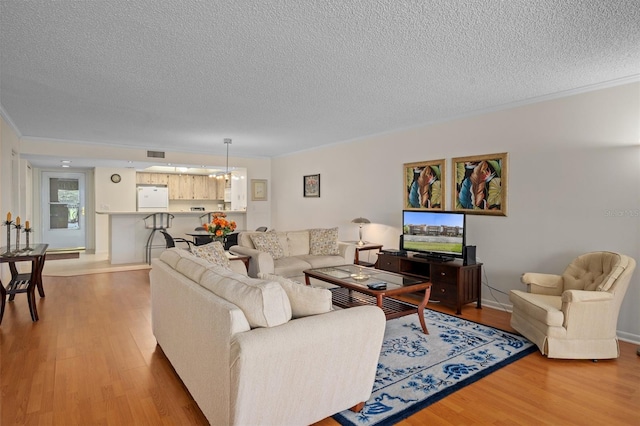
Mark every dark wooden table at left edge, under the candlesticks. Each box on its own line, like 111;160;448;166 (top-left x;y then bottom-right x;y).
0;244;49;324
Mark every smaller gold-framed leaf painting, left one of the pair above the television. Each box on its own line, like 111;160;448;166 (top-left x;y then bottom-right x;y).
402;159;446;210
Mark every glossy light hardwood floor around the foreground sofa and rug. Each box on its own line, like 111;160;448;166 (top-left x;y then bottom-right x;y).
0;270;640;426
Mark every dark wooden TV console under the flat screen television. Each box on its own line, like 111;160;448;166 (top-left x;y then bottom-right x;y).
377;252;482;315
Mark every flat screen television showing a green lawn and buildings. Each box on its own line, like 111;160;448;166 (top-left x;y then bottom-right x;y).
400;210;466;260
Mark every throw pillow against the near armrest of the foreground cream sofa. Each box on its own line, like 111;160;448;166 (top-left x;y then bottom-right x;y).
258;272;332;318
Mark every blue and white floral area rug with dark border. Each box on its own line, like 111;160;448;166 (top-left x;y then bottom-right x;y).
333;309;536;426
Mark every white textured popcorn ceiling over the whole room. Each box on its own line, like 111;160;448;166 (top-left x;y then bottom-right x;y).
0;0;640;166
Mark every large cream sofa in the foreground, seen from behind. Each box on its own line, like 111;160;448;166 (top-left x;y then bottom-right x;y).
150;248;385;425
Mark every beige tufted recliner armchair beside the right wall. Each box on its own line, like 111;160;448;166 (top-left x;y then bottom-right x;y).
509;252;636;360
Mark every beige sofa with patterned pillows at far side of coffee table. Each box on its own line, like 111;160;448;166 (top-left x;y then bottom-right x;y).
229;228;356;282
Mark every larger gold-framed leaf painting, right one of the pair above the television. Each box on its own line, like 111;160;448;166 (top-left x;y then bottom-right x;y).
451;152;508;216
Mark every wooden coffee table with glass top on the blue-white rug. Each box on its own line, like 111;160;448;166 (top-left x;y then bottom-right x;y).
303;265;431;334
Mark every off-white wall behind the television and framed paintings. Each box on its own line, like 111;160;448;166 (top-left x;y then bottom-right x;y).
272;83;640;342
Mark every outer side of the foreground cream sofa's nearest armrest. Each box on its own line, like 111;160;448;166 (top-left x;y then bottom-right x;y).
231;306;386;424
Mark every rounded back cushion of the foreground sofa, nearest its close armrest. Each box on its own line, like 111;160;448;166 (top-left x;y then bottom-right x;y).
199;265;291;328
